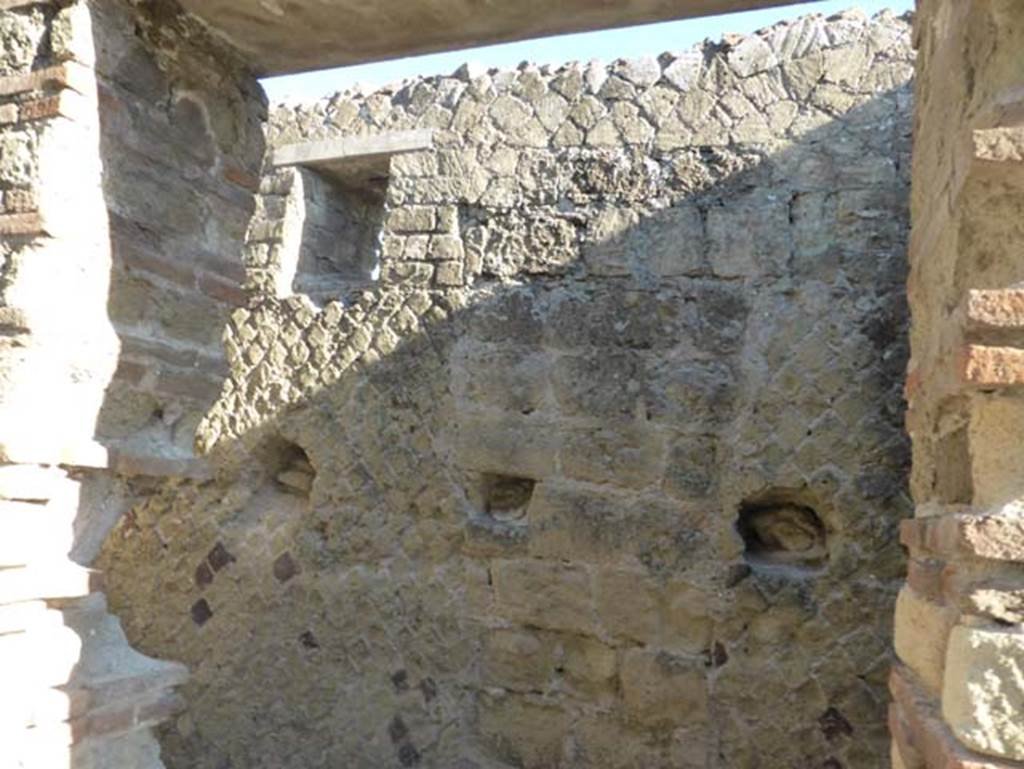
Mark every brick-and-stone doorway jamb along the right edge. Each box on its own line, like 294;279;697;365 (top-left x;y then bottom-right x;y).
890;0;1024;769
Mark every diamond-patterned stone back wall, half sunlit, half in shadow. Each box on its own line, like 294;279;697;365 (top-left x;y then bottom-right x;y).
99;13;911;769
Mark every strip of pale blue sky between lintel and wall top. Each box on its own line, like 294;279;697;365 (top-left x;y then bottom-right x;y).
263;0;913;103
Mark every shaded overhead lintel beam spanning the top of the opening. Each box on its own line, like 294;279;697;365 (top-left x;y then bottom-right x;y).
174;0;813;75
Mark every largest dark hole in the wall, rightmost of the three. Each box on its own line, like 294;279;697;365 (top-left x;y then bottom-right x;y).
736;497;828;570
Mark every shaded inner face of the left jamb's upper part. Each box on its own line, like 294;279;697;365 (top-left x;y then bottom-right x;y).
91;2;266;466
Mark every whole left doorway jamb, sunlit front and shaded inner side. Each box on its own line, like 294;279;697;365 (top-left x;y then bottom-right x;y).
0;0;265;769
